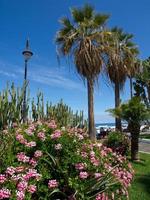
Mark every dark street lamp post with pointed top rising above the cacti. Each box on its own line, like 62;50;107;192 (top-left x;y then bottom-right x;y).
22;39;33;123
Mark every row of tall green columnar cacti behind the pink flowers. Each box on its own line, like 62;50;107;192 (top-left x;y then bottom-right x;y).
0;83;86;130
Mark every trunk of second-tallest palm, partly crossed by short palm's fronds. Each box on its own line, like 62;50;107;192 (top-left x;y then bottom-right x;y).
115;83;122;131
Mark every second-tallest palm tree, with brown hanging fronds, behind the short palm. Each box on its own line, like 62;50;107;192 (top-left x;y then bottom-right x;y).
106;27;138;131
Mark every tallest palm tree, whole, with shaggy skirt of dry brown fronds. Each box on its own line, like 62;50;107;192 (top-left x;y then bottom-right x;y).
56;5;109;140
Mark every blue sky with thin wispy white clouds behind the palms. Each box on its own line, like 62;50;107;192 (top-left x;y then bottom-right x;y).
0;0;150;122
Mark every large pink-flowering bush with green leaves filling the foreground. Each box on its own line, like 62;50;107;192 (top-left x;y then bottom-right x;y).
0;121;133;200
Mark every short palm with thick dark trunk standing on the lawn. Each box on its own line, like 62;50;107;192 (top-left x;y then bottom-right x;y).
108;97;150;160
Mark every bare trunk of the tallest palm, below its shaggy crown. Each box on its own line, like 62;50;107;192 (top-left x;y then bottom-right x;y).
87;79;96;140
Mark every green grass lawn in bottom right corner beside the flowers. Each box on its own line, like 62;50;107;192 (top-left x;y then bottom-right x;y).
129;153;150;200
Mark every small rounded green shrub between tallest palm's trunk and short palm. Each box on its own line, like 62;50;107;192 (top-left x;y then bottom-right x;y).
104;132;130;155
